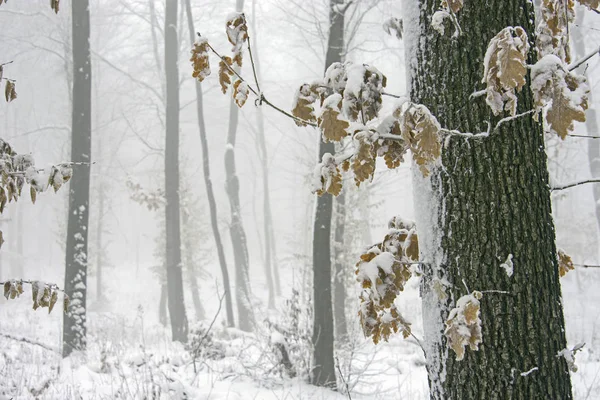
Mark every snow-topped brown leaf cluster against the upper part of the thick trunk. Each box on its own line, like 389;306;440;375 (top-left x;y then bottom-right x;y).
482;26;529;115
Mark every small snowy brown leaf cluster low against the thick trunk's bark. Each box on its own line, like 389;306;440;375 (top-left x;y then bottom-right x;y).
444;291;483;361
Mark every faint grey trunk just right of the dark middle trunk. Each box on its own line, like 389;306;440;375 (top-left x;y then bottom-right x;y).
333;192;348;343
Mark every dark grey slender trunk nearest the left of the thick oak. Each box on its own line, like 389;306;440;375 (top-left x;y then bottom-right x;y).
311;0;344;387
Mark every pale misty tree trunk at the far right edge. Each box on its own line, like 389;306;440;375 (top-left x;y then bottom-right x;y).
571;11;600;241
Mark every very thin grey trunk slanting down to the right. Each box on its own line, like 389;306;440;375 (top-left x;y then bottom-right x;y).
185;0;234;326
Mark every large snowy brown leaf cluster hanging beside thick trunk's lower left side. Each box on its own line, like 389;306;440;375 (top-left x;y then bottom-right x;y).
355;219;418;344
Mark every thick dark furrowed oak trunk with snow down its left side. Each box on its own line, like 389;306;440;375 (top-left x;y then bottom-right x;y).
406;0;572;399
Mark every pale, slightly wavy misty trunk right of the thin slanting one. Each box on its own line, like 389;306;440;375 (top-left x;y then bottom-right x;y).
225;0;254;332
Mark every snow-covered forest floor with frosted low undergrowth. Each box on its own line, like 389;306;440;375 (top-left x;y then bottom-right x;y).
0;260;600;400
